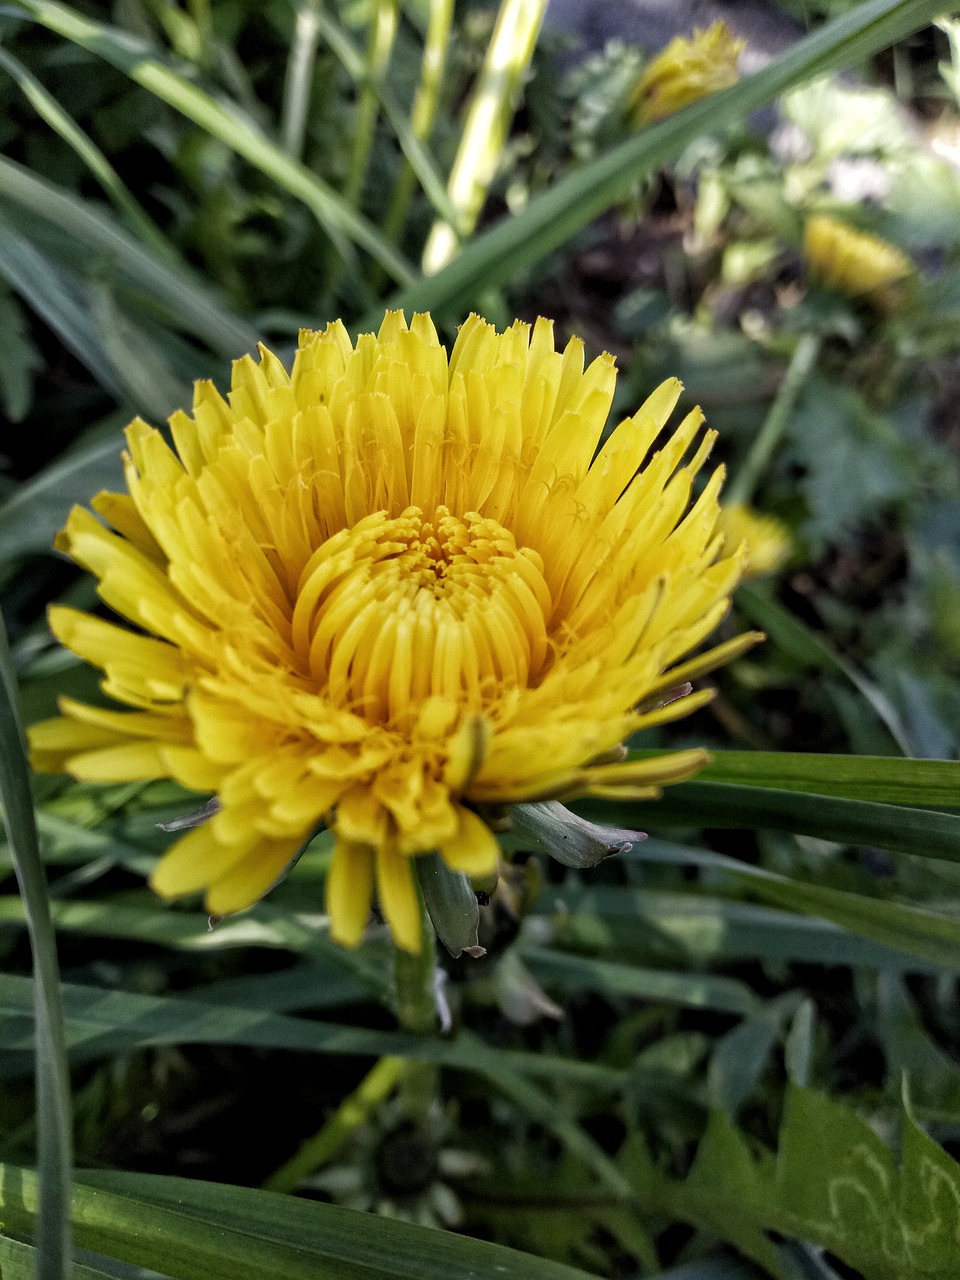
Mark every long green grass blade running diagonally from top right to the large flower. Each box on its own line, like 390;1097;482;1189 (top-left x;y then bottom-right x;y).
357;0;943;329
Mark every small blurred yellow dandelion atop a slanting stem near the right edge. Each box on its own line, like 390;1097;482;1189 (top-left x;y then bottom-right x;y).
804;214;914;308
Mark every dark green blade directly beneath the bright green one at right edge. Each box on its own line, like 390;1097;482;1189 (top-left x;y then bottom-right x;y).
591;781;960;863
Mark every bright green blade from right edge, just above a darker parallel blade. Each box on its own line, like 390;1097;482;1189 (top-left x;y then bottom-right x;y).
686;751;960;809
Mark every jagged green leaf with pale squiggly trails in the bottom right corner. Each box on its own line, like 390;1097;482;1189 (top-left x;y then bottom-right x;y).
634;1084;960;1280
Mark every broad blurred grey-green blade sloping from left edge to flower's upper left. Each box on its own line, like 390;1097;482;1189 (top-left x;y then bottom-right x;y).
0;156;259;358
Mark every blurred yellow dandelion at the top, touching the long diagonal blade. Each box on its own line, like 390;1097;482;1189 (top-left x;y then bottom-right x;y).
628;22;746;127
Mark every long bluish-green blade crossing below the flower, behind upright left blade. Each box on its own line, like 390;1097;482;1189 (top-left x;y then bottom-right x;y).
0;974;623;1089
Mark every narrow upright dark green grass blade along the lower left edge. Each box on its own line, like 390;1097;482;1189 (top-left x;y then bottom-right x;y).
0;621;72;1280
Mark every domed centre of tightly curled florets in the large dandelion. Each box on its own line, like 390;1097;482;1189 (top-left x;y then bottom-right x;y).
292;507;552;727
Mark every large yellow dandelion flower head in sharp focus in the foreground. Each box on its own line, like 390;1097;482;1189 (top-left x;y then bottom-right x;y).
32;312;750;951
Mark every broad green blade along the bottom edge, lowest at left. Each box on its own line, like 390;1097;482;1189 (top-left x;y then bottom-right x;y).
0;1165;588;1280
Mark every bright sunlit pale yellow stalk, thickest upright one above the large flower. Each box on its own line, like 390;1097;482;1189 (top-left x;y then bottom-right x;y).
424;0;547;275
